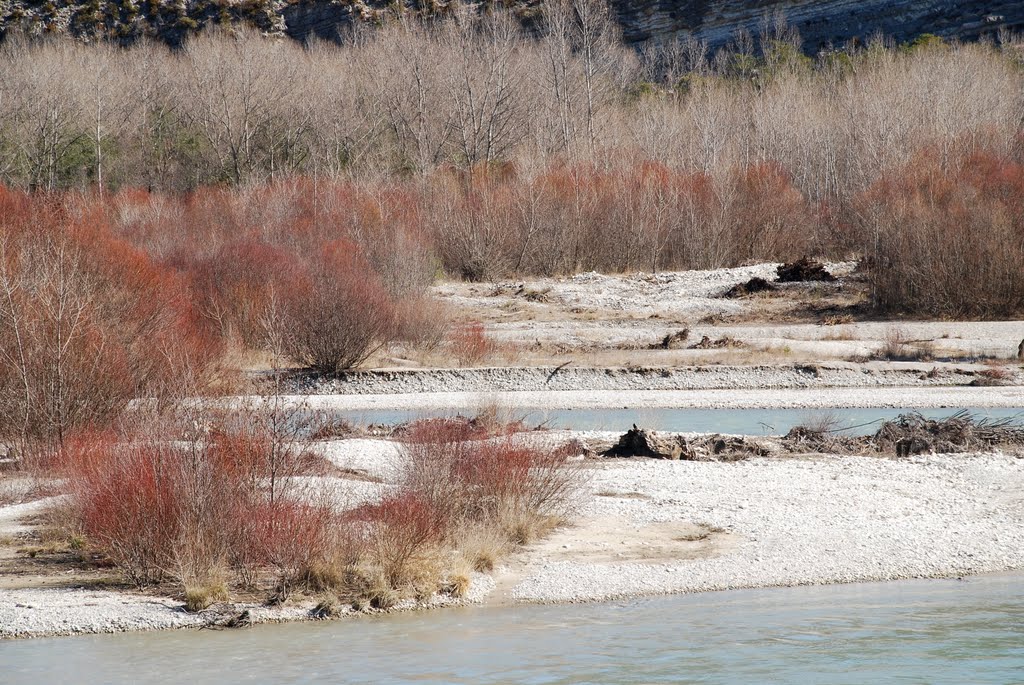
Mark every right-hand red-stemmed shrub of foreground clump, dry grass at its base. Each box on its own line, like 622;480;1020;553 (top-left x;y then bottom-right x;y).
319;420;575;608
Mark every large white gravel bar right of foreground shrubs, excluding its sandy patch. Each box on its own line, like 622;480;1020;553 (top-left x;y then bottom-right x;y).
511;455;1024;602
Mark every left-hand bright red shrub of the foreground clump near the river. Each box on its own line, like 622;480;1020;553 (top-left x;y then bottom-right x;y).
62;409;336;594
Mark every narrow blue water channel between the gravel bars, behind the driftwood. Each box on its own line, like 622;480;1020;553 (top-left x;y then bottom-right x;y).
331;408;1024;435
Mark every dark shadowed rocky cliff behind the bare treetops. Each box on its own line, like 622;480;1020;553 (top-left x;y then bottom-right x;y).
0;0;1024;52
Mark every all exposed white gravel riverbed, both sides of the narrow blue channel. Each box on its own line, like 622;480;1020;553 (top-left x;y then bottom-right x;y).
0;262;1024;638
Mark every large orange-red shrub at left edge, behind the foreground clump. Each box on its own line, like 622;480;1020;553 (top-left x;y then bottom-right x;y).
0;191;218;454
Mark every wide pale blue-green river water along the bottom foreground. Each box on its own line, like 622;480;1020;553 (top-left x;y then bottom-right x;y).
0;574;1024;685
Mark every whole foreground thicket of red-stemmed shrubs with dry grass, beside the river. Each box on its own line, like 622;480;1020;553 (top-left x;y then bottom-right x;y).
61;406;578;609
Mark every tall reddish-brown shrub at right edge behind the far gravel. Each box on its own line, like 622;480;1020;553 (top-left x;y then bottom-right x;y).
856;147;1024;317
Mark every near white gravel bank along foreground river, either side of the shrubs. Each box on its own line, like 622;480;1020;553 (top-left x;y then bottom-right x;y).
0;433;1024;638
